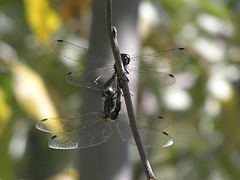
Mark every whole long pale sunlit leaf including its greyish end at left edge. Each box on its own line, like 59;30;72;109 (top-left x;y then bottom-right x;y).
0;43;58;120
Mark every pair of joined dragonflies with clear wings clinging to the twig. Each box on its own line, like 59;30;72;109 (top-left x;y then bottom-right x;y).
36;40;190;149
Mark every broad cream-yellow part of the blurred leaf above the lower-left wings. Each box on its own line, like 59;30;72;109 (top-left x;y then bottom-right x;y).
11;63;57;120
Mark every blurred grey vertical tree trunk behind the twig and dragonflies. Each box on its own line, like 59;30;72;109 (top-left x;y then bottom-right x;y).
77;0;139;180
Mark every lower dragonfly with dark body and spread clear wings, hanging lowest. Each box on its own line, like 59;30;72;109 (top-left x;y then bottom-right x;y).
36;86;173;149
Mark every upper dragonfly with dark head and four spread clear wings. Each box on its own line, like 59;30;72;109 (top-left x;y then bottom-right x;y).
51;40;190;91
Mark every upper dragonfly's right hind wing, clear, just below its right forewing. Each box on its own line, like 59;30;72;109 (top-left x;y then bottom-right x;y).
127;67;175;91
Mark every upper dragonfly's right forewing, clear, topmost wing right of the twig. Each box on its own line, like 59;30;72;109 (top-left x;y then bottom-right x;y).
130;48;191;71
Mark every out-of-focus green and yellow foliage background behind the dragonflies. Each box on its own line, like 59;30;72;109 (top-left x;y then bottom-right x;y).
0;0;240;180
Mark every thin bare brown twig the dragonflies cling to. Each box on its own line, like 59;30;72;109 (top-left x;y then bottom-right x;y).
106;0;156;180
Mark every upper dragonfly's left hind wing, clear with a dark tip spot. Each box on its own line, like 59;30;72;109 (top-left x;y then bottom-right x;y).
66;66;115;90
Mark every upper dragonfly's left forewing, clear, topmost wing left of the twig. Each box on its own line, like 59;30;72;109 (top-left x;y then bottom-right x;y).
51;40;114;66
